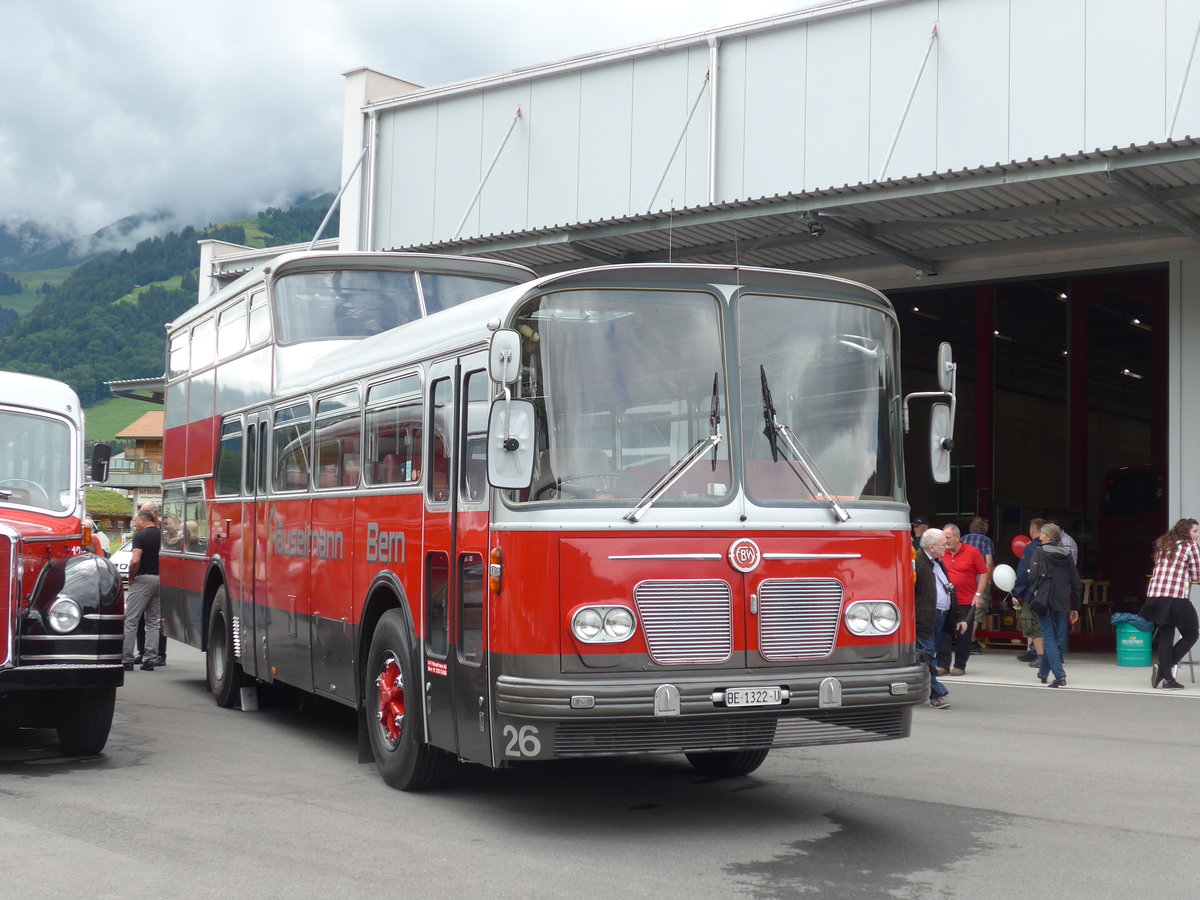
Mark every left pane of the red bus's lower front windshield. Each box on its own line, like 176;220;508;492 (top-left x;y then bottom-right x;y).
514;289;732;505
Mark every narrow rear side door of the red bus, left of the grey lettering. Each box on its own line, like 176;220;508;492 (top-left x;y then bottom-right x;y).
239;413;270;679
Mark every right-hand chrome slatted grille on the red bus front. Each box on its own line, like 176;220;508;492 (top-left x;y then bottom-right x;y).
758;578;842;660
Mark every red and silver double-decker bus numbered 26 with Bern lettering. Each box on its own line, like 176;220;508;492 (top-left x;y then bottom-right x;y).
161;252;950;790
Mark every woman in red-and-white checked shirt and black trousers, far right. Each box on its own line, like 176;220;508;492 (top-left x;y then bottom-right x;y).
1139;518;1200;690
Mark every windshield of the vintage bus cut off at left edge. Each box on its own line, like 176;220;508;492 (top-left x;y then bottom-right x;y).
0;409;74;512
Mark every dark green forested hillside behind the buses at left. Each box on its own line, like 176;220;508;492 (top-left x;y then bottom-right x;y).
0;197;337;406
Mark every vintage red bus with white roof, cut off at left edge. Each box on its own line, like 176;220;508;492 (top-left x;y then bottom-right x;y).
0;372;125;755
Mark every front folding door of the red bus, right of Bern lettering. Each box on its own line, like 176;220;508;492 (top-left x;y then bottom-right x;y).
424;353;492;764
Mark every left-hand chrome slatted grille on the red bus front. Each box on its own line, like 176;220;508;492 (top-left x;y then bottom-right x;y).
634;581;733;665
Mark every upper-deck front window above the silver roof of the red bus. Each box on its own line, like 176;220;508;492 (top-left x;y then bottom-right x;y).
274;269;518;344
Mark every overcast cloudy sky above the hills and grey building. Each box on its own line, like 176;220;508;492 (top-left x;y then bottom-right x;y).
0;0;817;240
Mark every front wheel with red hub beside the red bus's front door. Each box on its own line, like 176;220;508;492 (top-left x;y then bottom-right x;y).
362;610;451;791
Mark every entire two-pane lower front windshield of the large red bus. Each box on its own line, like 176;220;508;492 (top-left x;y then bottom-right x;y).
508;289;901;509
